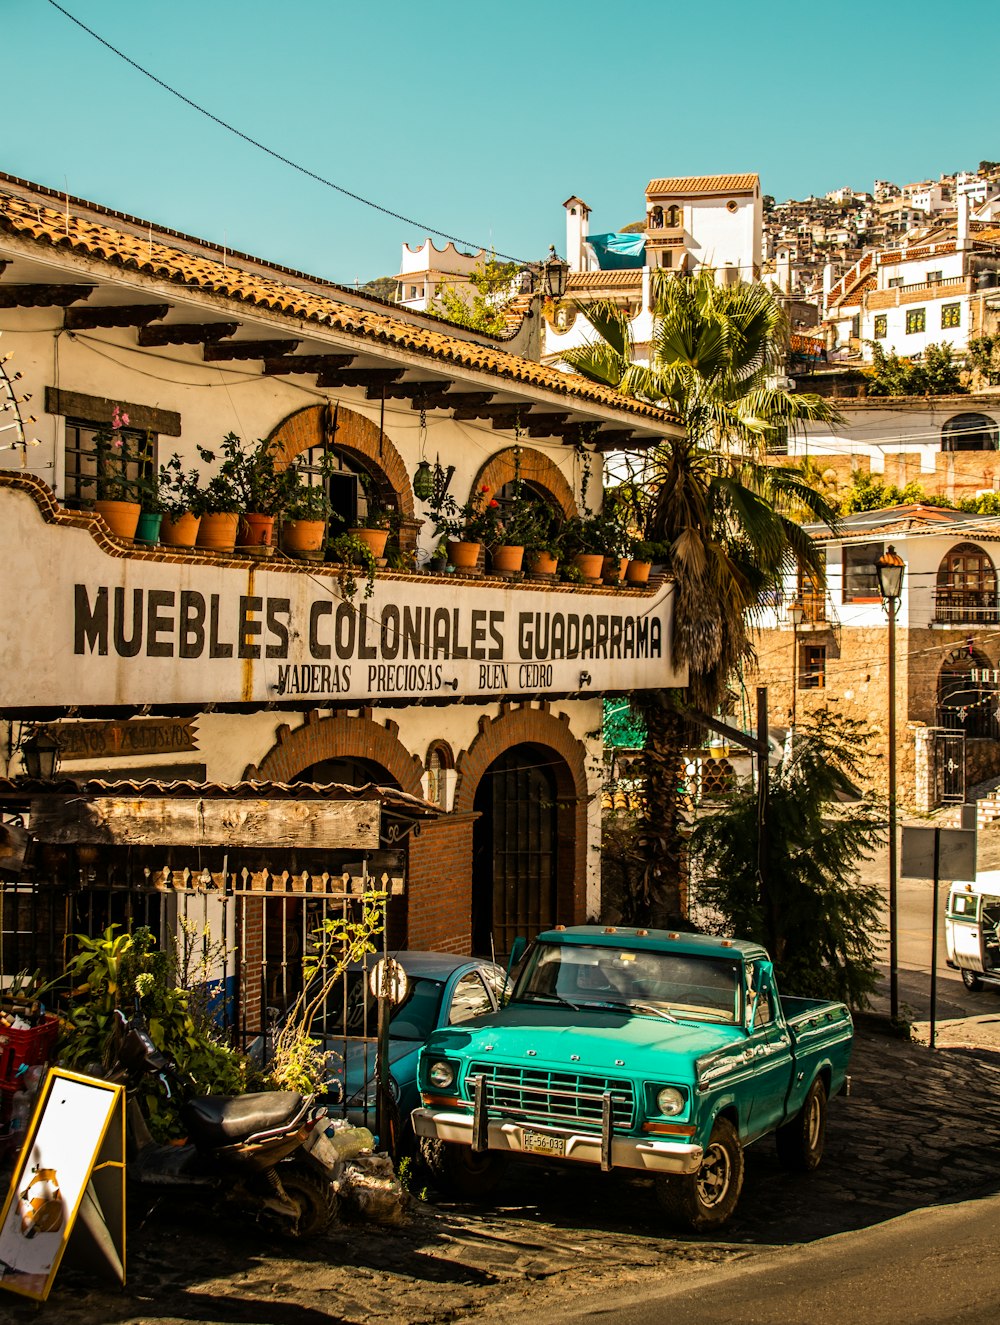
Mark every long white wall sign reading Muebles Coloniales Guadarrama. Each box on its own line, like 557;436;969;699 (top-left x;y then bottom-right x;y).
0;489;686;710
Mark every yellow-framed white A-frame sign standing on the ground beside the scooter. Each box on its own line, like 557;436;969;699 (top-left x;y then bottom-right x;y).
0;1068;125;1301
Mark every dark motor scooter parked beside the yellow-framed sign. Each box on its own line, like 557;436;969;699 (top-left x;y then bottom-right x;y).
111;1011;339;1238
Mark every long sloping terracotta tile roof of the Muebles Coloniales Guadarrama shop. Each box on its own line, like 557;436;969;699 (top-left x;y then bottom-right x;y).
0;191;675;425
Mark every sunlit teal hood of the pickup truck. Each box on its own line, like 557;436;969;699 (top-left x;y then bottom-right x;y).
424;1003;746;1080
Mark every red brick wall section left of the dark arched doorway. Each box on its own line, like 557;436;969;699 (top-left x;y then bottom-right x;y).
407;814;477;954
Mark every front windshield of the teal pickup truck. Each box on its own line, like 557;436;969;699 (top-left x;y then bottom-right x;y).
514;943;740;1023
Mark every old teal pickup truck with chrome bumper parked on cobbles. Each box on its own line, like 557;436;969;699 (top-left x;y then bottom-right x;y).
413;925;853;1230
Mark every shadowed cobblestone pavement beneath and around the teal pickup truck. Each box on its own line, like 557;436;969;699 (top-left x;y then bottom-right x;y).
0;1020;1000;1325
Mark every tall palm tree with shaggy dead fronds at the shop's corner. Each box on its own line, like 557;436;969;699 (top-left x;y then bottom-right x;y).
563;269;838;925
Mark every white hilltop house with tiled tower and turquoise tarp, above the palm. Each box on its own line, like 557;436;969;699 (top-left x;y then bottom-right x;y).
542;174;764;362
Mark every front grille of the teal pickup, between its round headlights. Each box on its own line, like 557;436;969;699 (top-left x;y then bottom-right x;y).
466;1063;636;1132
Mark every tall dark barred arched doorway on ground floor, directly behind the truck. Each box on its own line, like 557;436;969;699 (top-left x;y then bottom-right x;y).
472;743;564;954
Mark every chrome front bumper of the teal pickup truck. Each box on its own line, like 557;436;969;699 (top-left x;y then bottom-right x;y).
412;1109;702;1174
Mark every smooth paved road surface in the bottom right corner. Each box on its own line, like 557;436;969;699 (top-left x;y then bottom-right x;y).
535;1196;1000;1325
